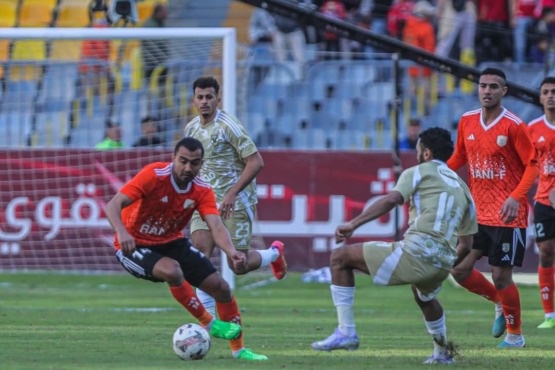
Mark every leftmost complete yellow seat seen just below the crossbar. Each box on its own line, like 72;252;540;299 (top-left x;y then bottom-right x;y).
9;40;46;81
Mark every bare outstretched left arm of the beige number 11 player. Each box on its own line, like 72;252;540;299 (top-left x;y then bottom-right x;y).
335;191;405;243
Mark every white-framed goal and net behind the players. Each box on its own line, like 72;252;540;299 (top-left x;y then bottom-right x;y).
0;28;249;280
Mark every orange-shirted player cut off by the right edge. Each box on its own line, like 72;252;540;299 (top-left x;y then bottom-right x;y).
528;76;555;329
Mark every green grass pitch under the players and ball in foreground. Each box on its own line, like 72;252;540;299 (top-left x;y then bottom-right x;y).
0;273;555;370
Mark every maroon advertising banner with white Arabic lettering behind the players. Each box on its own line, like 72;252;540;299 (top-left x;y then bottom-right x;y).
0;150;538;272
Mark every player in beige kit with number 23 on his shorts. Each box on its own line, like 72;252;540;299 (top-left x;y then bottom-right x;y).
185;77;287;311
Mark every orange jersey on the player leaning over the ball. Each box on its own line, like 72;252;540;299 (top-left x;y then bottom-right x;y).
114;162;219;249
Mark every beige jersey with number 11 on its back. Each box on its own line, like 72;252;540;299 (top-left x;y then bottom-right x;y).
393;160;478;269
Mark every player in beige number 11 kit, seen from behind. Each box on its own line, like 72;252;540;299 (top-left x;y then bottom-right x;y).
312;127;478;364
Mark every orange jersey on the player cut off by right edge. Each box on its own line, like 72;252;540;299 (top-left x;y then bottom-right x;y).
528;115;555;206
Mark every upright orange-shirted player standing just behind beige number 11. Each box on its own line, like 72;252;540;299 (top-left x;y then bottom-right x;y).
447;68;539;348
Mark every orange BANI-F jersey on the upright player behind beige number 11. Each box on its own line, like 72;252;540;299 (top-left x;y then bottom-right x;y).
453;108;536;228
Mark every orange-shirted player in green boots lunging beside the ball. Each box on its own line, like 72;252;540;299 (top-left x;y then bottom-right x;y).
106;138;268;360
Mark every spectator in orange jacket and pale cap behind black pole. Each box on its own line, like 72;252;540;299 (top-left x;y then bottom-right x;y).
403;0;436;112
